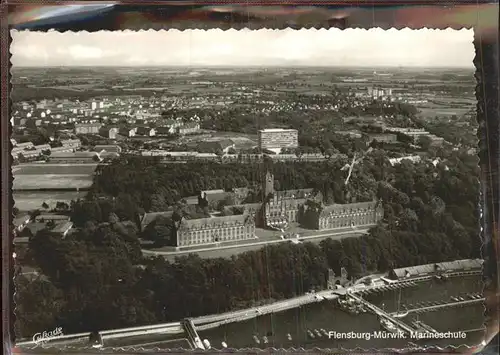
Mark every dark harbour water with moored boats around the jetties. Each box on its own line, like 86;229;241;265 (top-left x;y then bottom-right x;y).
199;276;484;348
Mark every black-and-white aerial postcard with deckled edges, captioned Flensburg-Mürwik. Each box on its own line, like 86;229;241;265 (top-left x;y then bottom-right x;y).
10;29;485;352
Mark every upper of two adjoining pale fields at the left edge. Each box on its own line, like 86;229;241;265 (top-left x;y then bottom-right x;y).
12;174;93;191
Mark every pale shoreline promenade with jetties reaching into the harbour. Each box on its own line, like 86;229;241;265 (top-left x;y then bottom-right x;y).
17;270;484;349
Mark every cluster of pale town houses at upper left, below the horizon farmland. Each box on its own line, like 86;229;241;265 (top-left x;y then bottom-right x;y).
11;96;200;145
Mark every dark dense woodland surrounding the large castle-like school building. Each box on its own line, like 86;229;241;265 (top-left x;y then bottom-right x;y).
16;140;480;337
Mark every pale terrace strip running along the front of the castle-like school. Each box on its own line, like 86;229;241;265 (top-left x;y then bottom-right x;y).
142;229;368;261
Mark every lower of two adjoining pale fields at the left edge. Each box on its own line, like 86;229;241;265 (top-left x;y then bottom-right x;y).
13;191;86;212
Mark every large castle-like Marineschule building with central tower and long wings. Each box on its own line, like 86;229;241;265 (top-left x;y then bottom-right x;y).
141;172;383;249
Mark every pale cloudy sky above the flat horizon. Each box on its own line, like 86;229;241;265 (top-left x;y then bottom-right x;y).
11;29;475;68
